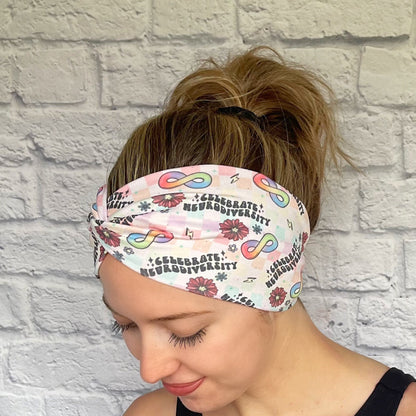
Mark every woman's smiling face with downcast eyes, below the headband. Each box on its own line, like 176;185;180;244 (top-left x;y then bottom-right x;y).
100;255;273;412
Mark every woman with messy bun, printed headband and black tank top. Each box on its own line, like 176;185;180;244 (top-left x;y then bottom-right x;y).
90;48;416;416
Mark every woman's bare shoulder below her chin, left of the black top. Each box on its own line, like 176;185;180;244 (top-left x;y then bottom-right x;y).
123;389;176;416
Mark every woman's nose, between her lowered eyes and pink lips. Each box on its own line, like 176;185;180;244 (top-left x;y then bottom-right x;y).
128;335;180;383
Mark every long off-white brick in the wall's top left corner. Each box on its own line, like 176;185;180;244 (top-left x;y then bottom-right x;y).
0;0;147;41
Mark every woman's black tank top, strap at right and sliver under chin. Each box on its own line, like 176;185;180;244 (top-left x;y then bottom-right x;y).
176;368;416;416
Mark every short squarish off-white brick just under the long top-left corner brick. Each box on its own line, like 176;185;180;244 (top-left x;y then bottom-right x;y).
16;48;87;104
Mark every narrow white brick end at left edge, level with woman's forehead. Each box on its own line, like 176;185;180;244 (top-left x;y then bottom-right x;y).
0;283;28;328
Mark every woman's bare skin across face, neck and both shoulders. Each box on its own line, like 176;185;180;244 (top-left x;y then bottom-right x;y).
100;256;416;416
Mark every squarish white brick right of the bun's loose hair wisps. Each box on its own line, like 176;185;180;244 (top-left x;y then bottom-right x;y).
342;113;402;167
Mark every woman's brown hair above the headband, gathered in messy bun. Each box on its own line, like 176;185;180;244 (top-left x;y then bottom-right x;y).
108;47;348;234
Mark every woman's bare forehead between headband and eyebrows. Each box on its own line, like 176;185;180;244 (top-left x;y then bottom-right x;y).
99;255;224;316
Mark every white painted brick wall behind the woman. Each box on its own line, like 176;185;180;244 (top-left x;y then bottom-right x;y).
0;0;416;416
